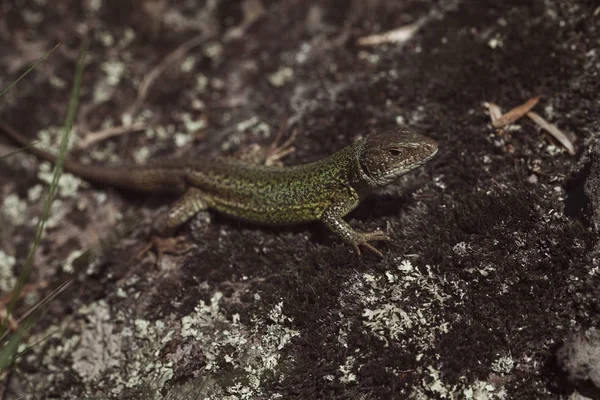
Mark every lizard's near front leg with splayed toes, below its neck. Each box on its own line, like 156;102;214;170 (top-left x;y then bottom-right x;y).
321;187;391;257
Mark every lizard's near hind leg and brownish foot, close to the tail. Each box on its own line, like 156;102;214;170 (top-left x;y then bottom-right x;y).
138;188;208;264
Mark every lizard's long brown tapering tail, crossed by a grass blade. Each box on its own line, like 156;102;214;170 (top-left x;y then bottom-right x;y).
0;122;185;193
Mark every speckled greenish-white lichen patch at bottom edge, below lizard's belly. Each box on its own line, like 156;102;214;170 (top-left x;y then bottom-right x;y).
179;292;298;400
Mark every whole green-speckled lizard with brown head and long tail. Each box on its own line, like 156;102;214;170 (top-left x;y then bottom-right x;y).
0;124;438;260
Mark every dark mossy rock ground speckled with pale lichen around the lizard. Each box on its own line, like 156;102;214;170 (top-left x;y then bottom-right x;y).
0;0;600;400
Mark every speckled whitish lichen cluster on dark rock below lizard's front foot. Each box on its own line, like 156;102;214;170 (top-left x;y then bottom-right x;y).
338;259;460;399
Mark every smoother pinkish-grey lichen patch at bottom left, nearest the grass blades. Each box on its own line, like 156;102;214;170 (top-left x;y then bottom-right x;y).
28;300;173;399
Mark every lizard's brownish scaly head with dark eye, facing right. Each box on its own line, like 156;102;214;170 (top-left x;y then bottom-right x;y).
359;128;438;186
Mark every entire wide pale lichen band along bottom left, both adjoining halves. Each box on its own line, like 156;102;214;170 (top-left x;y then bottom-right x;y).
23;292;298;400
